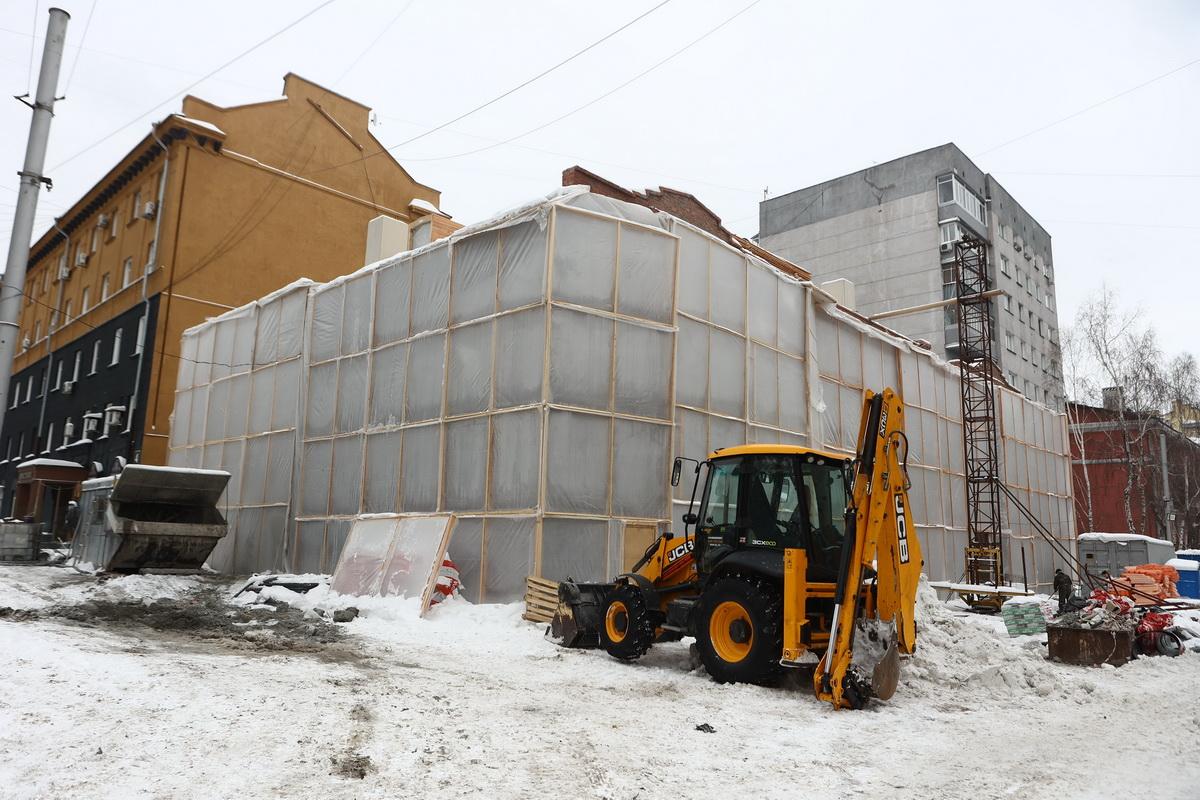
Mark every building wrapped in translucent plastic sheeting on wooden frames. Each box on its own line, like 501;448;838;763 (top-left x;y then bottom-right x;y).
170;187;1074;601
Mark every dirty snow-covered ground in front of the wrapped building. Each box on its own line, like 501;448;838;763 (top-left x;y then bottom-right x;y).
0;567;1200;800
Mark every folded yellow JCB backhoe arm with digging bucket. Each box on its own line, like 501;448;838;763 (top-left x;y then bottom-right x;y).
814;389;922;708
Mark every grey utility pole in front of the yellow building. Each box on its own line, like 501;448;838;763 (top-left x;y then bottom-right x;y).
0;8;71;438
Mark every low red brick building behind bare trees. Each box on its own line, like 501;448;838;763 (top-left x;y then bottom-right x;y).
1067;403;1200;548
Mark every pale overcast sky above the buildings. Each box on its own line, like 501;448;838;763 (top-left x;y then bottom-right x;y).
7;0;1200;367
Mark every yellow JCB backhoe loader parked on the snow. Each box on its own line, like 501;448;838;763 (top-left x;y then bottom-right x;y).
551;389;922;709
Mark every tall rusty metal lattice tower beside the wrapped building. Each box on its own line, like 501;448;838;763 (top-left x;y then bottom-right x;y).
954;236;1004;609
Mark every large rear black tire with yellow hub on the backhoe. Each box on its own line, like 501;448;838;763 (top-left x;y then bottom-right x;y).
696;575;784;686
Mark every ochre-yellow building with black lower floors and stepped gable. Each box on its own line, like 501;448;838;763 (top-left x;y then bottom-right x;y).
0;73;457;512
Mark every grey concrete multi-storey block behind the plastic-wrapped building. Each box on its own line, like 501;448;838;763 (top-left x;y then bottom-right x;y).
758;143;1063;409
